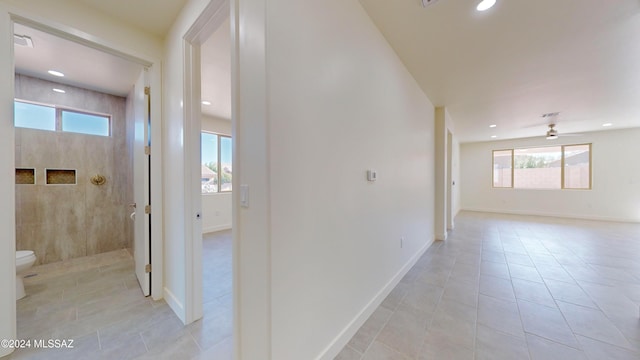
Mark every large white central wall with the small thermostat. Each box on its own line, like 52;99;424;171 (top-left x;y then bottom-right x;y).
267;0;434;359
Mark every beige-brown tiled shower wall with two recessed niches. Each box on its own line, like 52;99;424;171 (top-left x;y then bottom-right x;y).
15;74;133;264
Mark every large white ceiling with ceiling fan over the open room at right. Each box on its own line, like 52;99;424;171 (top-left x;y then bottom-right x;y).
360;0;640;142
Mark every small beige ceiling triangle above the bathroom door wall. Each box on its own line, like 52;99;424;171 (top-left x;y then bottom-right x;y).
75;0;188;38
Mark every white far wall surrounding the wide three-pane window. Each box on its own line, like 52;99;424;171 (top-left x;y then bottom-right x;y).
461;128;640;222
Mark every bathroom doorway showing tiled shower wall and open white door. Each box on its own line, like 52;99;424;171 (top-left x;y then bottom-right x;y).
13;19;162;338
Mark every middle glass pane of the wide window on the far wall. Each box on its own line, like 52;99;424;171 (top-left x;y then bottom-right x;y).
513;146;562;189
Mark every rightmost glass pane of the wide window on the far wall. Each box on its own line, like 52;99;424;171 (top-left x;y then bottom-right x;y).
564;144;591;189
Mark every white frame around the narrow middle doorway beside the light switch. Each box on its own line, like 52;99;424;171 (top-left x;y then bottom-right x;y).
183;0;272;360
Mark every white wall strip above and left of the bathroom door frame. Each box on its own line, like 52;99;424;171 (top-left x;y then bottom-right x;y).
0;0;162;356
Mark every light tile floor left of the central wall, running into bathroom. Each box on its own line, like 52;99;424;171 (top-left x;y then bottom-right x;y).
7;231;233;360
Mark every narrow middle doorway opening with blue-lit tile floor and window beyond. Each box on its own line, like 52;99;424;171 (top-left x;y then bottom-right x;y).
185;1;234;358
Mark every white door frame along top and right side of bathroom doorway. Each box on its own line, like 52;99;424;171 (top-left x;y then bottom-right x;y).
2;11;164;300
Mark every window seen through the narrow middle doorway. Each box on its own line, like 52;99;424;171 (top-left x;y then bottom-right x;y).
201;132;233;194
